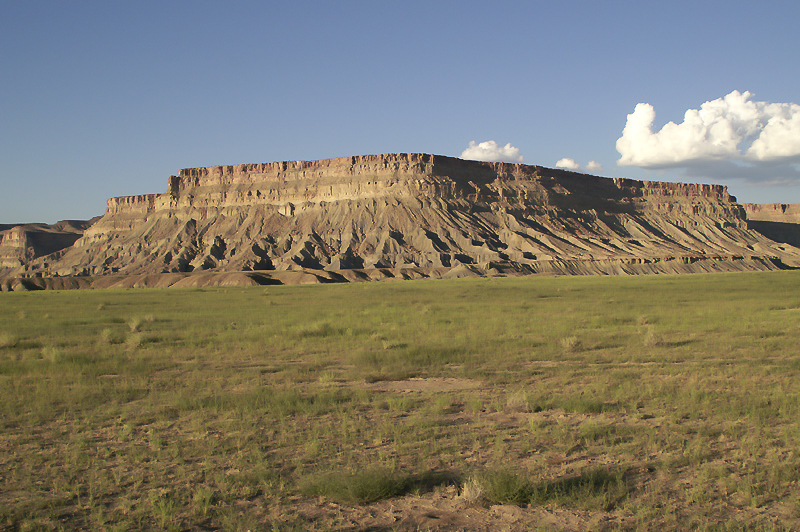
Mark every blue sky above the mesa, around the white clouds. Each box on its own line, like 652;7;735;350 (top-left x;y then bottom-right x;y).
0;0;800;223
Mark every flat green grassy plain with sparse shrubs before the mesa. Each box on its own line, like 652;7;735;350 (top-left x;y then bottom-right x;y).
0;272;800;531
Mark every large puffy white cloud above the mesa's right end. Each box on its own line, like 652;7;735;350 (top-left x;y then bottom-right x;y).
617;91;800;168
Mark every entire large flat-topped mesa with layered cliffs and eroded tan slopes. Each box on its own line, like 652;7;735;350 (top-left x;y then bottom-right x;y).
6;154;800;286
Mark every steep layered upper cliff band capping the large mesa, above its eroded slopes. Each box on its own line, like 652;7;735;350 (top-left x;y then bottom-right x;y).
159;153;744;220
